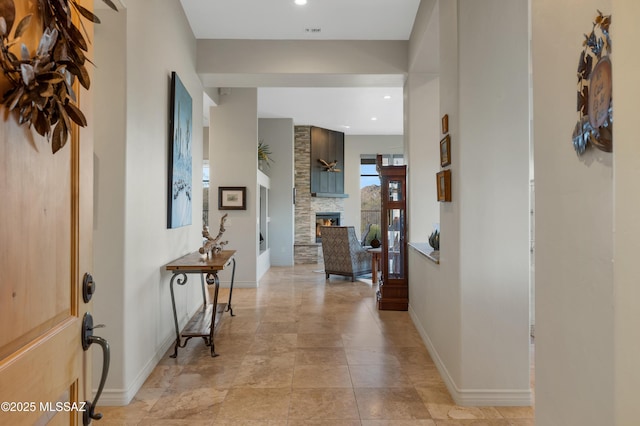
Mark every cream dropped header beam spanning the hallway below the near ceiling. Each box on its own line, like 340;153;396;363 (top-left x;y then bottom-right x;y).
197;40;407;87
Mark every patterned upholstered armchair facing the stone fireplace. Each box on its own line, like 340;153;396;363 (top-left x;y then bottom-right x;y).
320;226;371;281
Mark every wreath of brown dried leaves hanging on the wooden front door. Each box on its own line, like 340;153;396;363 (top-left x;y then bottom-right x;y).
0;0;117;154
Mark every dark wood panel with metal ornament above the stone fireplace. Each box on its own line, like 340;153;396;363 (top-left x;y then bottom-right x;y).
310;126;347;198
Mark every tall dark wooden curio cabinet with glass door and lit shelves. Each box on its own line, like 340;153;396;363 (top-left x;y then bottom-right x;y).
376;155;409;311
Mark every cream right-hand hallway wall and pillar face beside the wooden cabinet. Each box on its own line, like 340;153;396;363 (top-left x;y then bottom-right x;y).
409;0;531;405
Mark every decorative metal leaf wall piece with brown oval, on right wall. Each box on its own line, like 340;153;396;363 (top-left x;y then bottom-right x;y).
573;10;613;155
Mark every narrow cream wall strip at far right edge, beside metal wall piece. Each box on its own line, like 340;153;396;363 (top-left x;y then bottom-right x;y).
611;0;640;425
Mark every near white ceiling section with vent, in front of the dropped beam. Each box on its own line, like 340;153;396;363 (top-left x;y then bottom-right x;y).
180;0;420;40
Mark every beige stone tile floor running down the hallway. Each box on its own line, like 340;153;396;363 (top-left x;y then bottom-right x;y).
98;265;534;426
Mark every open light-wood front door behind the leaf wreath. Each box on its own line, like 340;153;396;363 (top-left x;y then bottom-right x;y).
0;1;93;425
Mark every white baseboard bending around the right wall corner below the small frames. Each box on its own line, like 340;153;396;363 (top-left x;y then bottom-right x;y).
409;305;533;407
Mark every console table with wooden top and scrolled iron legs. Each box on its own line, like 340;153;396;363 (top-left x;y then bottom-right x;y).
165;250;236;358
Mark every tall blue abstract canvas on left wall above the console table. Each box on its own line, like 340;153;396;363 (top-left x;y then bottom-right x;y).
167;71;192;228
